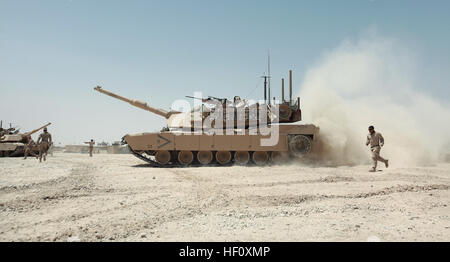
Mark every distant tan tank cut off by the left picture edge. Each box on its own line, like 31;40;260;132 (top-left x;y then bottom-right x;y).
0;123;51;157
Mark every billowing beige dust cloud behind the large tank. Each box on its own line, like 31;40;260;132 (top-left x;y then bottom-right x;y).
300;32;450;166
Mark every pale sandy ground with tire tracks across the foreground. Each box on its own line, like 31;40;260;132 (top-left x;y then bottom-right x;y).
0;153;450;241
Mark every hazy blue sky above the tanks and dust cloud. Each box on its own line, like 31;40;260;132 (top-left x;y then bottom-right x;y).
0;0;450;143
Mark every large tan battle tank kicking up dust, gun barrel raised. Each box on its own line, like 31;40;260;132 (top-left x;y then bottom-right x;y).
94;71;319;167
